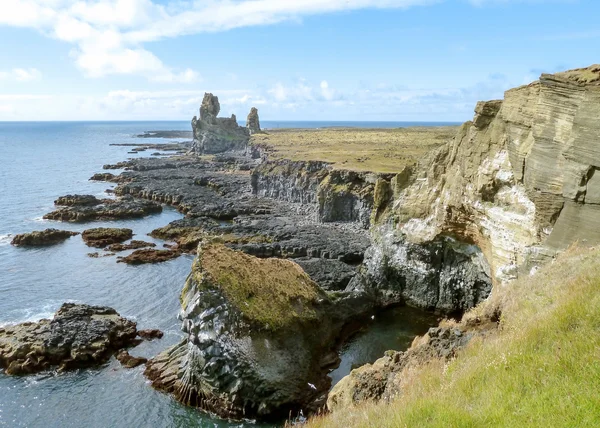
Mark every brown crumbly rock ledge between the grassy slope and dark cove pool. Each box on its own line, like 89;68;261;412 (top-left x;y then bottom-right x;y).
327;327;474;412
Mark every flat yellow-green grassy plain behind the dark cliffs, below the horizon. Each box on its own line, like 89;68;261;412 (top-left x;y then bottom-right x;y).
251;126;458;173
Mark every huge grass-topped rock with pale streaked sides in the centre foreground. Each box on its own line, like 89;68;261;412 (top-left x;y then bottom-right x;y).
146;244;372;419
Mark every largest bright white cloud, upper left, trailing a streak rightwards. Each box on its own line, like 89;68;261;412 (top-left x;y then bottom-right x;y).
0;0;440;83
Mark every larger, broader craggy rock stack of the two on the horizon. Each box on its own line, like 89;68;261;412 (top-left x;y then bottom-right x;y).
191;93;250;154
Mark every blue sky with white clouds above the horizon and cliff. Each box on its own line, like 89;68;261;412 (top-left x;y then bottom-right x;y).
0;0;600;122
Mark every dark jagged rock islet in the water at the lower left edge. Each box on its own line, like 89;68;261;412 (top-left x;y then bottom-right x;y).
0;303;137;375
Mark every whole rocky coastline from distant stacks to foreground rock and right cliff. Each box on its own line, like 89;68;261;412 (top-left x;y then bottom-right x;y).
9;67;600;420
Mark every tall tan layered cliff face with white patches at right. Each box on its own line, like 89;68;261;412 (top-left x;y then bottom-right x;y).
376;66;600;284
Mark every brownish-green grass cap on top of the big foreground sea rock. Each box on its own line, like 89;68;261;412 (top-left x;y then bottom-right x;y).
193;244;327;330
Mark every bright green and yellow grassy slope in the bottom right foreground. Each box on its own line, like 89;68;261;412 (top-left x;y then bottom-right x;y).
310;249;600;428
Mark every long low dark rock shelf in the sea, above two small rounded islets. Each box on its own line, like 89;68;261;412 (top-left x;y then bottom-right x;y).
44;195;162;222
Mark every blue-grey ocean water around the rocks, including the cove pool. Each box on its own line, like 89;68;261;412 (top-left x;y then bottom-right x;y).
0;121;440;428
